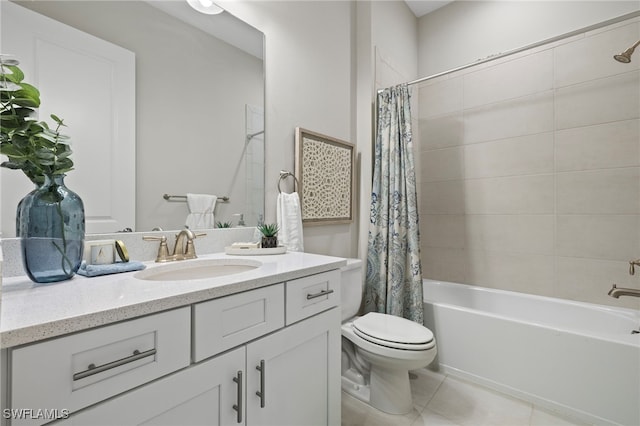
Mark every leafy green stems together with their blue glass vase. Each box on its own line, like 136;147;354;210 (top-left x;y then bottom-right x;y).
0;55;85;282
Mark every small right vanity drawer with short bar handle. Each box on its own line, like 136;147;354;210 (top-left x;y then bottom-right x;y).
286;269;340;325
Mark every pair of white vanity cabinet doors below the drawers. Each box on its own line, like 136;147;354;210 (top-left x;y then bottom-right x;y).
62;308;340;426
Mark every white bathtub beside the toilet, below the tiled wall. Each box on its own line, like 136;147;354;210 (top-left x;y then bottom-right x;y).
423;280;640;426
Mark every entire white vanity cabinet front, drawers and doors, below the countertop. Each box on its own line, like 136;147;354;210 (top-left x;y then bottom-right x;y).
5;270;341;426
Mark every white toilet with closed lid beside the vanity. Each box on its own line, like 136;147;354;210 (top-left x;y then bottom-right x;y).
341;259;436;414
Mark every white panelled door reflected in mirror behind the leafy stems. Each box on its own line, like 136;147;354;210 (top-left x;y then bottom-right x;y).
0;1;136;237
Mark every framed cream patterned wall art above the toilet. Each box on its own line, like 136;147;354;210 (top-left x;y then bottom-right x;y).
295;127;355;225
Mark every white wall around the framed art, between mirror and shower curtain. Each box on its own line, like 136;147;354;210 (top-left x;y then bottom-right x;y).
226;1;417;257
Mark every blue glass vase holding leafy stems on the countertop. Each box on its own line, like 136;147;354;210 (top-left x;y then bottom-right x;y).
16;175;85;283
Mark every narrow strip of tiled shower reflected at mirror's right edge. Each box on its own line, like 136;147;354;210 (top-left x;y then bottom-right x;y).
242;105;264;226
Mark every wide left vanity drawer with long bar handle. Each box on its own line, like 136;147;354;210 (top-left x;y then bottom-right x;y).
10;307;191;425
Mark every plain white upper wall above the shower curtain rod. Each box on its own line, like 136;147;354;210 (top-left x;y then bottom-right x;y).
418;0;638;77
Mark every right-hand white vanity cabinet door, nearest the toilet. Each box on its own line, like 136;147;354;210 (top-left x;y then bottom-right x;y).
247;308;340;426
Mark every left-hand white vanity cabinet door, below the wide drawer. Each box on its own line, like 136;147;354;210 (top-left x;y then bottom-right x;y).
56;347;245;426
